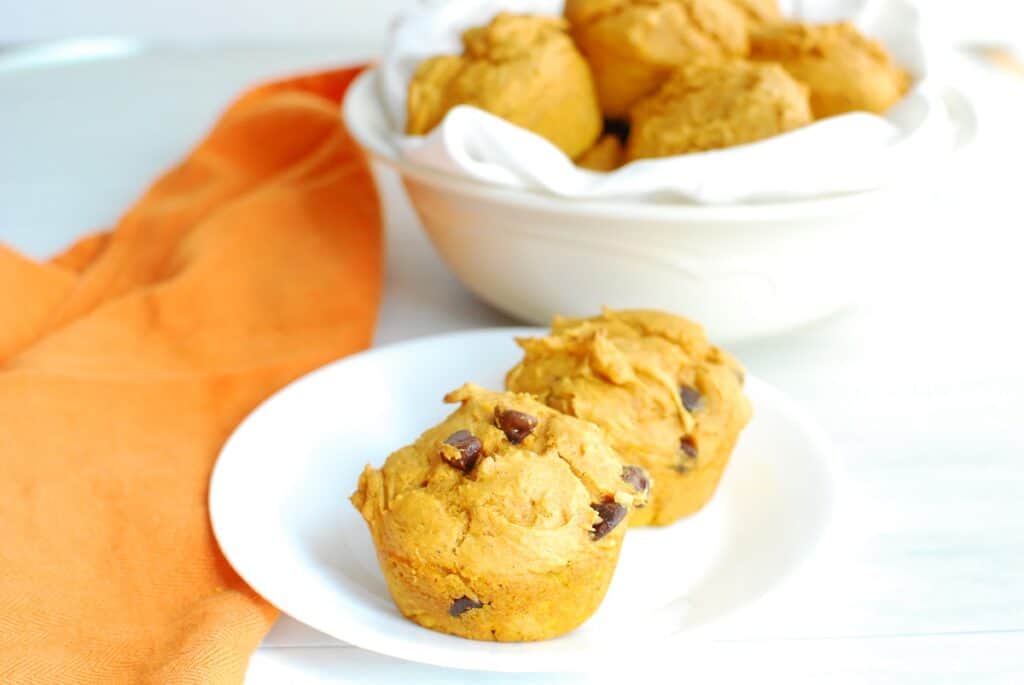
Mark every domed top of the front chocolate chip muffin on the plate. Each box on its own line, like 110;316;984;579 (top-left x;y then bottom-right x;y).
352;384;649;581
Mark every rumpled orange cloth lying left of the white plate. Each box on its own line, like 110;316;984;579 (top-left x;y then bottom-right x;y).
0;70;381;685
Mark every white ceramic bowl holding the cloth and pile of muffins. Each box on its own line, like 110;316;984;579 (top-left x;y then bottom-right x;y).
343;71;966;343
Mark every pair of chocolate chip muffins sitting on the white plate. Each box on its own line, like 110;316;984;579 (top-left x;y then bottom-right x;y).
351;310;751;641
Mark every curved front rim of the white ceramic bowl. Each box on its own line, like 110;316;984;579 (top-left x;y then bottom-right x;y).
341;66;921;222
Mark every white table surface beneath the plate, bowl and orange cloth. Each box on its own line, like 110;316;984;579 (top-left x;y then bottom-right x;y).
0;42;1024;685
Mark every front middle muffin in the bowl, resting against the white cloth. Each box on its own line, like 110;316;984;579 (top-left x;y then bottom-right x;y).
627;59;813;160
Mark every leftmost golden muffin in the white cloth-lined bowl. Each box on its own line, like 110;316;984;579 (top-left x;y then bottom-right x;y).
406;13;601;159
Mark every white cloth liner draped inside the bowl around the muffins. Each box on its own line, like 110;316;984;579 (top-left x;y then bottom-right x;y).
379;0;953;204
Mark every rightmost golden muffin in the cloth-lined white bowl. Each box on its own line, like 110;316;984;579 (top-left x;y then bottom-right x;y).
751;22;910;119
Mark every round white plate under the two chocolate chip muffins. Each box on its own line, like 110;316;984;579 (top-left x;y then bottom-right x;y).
210;329;834;672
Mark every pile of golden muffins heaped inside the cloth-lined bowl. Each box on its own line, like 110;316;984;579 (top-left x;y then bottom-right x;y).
407;0;910;171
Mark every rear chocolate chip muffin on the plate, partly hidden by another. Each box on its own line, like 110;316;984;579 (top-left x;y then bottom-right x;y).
506;310;751;525
